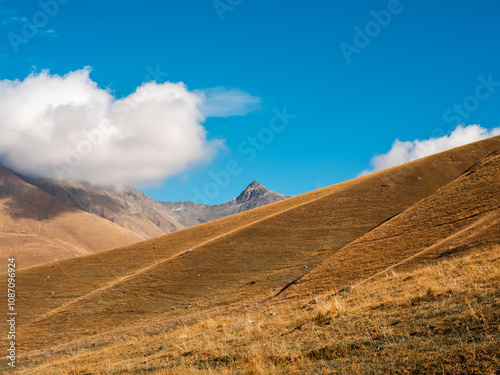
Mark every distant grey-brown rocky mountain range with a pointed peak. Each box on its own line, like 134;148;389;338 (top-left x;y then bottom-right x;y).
25;178;288;238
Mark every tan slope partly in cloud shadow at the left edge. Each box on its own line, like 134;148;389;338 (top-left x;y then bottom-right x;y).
0;167;143;268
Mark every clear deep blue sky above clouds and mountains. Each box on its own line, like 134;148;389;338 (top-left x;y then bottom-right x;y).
0;0;500;204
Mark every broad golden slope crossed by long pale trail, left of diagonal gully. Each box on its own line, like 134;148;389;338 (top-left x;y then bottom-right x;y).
11;137;500;348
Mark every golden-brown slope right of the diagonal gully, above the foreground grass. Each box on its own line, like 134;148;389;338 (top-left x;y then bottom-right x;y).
291;148;500;294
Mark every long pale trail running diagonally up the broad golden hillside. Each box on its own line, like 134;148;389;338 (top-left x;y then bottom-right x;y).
23;187;340;328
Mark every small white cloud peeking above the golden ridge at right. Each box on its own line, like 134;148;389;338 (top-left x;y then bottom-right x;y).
360;125;500;176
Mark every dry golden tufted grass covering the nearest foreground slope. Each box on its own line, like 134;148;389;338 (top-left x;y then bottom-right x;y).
13;246;500;375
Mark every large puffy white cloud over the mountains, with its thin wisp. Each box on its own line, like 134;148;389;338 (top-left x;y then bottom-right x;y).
0;68;257;185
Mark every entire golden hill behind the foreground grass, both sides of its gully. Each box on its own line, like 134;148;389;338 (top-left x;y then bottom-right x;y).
3;137;500;373
